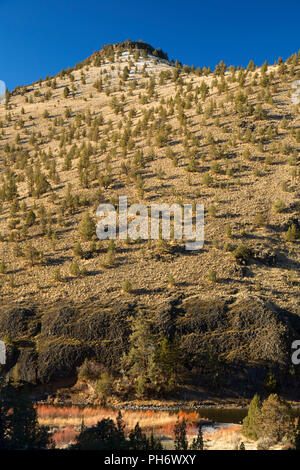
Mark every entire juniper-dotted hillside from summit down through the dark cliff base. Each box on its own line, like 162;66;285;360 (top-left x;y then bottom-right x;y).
0;42;300;399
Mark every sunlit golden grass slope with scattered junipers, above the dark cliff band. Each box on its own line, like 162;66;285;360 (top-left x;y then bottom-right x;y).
0;43;300;396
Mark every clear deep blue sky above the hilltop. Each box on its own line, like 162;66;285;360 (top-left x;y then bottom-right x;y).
0;0;300;90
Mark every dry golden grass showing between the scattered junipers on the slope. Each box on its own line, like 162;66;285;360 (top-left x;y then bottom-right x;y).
0;47;299;311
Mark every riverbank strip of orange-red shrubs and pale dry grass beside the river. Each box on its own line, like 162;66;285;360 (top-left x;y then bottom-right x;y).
37;405;282;450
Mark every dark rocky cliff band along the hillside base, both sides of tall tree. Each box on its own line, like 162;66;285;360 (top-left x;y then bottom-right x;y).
0;295;300;395
